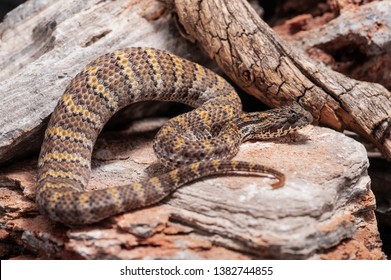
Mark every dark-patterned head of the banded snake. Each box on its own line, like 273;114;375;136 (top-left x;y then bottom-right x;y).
237;102;313;140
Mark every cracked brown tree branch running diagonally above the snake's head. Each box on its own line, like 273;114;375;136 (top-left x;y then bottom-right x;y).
162;0;391;159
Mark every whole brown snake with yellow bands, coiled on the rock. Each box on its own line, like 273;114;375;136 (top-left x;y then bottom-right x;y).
36;48;312;225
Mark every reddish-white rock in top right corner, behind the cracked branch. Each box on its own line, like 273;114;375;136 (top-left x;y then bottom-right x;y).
273;1;391;90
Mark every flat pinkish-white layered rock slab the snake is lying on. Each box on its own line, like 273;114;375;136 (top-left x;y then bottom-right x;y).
0;120;385;259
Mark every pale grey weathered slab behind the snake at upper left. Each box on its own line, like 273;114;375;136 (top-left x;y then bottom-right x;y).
0;0;214;165
